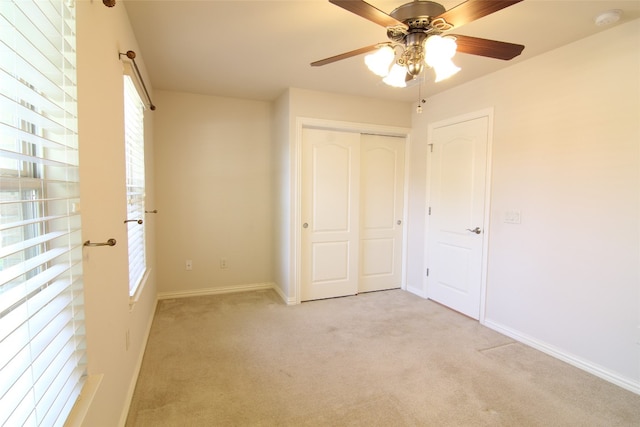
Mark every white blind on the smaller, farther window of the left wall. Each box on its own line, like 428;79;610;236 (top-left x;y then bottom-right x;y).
124;74;147;296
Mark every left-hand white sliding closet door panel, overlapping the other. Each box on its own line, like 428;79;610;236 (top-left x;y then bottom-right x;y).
300;128;360;301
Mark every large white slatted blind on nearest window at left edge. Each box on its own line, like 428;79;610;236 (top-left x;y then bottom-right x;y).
0;0;86;426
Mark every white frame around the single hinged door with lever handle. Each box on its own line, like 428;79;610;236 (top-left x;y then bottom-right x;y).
422;107;493;324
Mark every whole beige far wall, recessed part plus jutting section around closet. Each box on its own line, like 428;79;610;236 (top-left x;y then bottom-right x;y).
154;89;411;301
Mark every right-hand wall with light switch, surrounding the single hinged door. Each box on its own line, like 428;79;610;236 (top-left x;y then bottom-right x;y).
412;20;640;392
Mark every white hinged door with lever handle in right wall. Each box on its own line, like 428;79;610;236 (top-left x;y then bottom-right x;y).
427;117;489;319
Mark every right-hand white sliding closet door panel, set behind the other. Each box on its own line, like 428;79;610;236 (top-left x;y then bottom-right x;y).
358;135;404;292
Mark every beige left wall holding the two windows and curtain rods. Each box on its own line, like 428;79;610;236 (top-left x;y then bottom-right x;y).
76;1;160;427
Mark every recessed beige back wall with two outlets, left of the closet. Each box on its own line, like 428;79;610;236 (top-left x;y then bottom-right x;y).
154;91;275;298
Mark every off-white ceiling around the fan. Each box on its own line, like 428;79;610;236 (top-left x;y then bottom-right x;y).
122;0;640;102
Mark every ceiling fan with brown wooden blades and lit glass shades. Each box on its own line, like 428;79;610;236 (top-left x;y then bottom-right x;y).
311;0;524;86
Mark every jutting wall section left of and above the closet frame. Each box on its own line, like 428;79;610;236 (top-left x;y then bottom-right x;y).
273;88;411;303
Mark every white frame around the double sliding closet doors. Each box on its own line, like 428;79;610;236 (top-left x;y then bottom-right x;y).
289;117;411;304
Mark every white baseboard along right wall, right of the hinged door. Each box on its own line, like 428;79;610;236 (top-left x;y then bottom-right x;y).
482;319;640;394
